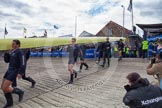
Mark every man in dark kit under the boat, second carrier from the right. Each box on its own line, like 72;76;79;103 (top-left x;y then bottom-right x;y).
101;38;111;67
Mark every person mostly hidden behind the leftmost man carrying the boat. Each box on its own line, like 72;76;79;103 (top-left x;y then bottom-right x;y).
12;49;36;88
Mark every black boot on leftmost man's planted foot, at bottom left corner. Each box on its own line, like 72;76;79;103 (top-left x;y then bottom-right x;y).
2;93;13;108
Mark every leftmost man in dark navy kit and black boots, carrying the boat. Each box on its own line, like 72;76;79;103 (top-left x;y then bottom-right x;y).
1;40;26;108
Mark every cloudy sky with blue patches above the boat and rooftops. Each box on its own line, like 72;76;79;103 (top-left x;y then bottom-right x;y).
0;0;162;38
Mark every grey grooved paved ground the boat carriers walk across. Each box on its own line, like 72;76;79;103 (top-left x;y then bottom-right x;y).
0;58;154;108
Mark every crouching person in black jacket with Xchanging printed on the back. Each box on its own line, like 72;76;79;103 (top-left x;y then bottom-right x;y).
123;73;162;108
